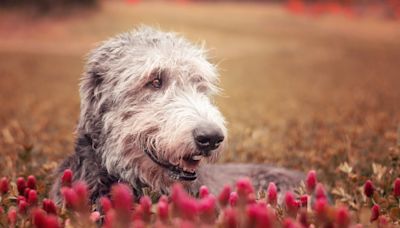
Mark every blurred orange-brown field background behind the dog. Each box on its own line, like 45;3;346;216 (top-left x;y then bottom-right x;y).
0;0;400;184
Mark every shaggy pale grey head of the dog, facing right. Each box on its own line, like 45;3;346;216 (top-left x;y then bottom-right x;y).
78;27;226;190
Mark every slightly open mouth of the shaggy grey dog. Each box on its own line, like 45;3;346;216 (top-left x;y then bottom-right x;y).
144;149;203;181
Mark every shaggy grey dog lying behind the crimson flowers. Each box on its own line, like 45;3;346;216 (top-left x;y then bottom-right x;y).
51;27;303;202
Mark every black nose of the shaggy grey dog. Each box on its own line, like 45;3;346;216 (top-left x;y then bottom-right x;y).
193;124;224;156
